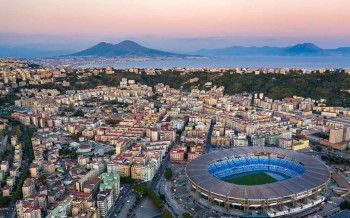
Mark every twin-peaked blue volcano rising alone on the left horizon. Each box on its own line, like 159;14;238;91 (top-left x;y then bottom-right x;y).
67;40;185;57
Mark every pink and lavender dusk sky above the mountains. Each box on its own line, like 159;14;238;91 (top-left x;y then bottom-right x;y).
0;0;350;51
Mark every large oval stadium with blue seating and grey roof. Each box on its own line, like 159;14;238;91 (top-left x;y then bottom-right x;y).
186;147;330;217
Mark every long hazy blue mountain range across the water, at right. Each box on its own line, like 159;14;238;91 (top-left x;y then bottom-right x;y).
194;43;350;56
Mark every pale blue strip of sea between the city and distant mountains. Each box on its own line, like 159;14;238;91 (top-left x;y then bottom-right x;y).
82;56;350;69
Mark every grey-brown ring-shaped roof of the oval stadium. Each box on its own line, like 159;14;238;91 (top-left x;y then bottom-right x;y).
186;147;330;200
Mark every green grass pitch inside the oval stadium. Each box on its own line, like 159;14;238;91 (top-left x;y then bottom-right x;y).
226;172;278;185
